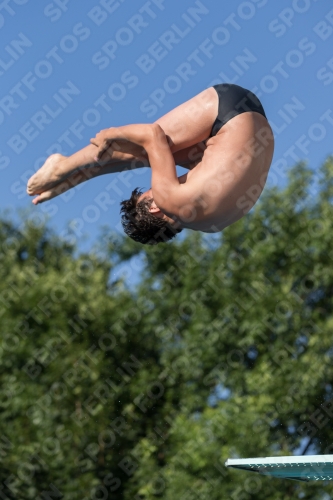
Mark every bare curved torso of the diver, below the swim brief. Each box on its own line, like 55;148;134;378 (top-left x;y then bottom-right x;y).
167;112;274;233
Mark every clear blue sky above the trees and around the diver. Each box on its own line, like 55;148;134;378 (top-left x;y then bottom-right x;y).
0;0;333;254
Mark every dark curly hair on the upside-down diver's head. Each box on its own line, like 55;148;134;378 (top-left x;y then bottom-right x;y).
120;188;181;245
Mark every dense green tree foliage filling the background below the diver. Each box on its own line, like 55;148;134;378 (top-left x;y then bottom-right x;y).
0;159;333;500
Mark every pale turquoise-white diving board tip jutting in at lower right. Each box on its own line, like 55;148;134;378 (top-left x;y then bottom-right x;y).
225;455;333;481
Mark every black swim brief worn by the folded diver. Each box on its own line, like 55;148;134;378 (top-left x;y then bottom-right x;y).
210;83;266;137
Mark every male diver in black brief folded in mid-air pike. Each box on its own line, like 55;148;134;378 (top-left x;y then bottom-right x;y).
27;84;274;244
